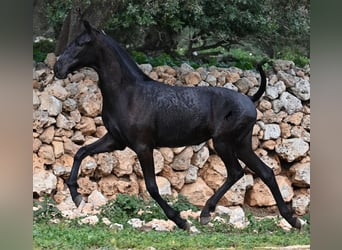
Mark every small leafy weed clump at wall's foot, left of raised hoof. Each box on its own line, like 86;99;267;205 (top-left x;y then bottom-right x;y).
33;196;62;222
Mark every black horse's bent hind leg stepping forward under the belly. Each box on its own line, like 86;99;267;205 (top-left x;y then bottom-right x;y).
200;140;244;224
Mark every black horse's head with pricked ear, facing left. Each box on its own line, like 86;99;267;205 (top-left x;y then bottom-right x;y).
53;21;97;79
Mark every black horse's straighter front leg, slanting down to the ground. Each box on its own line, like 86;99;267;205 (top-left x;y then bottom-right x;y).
136;147;190;231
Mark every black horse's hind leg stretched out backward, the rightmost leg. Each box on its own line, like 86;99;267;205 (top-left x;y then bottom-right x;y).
237;134;301;229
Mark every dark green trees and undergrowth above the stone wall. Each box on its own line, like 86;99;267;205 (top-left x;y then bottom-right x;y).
34;0;310;60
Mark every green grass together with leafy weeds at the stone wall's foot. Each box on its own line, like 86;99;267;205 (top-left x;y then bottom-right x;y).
33;195;310;250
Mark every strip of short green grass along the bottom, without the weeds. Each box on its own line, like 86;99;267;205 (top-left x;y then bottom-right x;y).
33;218;310;249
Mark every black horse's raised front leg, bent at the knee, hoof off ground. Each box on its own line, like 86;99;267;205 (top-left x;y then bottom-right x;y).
67;133;120;207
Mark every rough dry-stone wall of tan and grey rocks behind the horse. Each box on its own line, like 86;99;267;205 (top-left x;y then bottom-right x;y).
33;54;310;215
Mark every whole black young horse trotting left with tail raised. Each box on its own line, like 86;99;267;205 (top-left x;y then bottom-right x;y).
54;21;301;230
